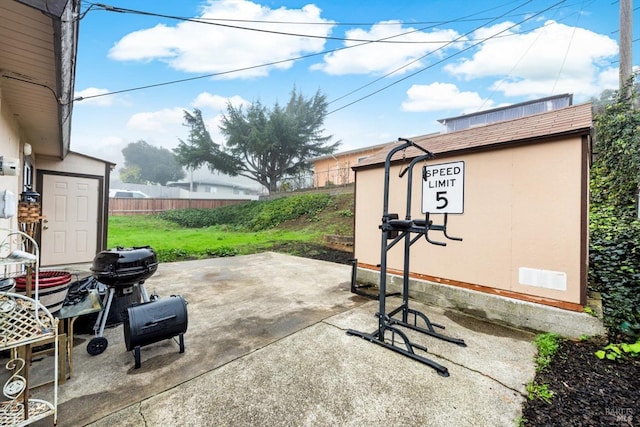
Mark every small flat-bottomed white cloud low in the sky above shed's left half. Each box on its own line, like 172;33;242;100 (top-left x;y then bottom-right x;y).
402;82;493;113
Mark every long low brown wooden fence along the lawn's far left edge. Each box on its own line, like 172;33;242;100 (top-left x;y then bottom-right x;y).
109;198;250;216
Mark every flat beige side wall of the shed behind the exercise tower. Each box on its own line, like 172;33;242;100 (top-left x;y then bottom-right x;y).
355;137;586;304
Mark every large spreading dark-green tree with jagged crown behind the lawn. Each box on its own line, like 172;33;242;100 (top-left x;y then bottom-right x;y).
174;89;339;191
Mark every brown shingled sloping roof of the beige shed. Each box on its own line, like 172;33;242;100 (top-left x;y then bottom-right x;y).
353;103;592;169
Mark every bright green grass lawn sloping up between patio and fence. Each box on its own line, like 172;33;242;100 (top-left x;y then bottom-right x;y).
107;193;353;262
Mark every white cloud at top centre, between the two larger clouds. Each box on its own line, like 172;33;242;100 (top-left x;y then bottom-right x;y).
311;21;461;75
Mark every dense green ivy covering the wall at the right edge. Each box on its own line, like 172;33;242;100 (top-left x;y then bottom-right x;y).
589;85;640;340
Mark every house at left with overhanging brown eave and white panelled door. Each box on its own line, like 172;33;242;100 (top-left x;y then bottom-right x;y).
0;0;114;266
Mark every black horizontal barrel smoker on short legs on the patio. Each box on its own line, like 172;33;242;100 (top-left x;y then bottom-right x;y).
124;295;188;369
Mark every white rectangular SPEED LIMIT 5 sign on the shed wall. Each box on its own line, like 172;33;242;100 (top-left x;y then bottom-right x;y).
422;162;464;214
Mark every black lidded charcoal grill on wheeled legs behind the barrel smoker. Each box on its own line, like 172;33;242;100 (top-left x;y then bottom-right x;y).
87;246;158;355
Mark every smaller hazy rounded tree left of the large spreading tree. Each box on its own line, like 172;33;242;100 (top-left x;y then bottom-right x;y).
120;140;185;185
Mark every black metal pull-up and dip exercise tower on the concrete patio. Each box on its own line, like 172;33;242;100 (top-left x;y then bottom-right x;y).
347;138;466;377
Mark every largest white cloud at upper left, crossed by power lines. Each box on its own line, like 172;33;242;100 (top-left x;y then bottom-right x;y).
109;0;332;79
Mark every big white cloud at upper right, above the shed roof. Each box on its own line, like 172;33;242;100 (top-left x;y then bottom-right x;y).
445;21;618;97
